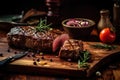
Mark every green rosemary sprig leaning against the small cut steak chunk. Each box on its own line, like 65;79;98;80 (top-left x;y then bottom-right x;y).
78;50;90;68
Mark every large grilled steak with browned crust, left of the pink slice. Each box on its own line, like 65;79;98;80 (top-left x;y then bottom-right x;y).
7;26;62;51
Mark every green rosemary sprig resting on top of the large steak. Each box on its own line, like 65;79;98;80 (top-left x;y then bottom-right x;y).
35;19;51;32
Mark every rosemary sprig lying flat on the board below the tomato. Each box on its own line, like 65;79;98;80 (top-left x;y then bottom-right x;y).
91;44;116;50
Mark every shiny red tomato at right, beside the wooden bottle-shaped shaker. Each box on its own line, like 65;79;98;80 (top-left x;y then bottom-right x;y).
99;28;116;43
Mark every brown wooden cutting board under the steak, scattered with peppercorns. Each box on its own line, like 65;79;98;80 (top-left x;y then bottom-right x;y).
0;38;120;77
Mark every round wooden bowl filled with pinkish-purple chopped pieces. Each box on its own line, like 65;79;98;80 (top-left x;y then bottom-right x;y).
62;18;95;39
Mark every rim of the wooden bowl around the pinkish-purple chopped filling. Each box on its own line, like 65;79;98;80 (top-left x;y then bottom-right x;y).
62;18;96;28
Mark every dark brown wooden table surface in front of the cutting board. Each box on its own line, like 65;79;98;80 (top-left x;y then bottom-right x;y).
0;66;120;80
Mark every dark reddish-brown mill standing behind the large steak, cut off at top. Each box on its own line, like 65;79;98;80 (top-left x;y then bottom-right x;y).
45;0;61;27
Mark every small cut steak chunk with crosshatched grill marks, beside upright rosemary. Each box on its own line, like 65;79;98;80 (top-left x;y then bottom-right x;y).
59;39;83;61
